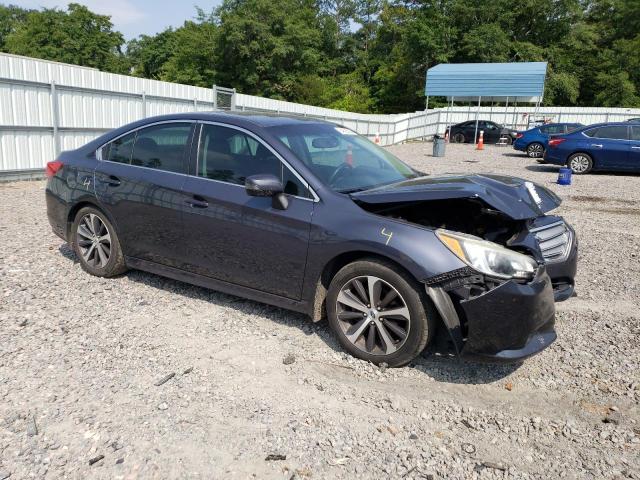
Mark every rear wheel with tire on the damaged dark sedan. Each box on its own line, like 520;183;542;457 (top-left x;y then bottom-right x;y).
70;207;127;277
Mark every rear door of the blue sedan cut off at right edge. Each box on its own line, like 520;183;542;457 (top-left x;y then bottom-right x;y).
586;125;630;169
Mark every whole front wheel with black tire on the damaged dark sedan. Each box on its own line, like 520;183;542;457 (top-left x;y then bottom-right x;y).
326;259;436;367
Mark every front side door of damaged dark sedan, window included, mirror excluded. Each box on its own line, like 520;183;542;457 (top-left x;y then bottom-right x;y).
184;123;314;299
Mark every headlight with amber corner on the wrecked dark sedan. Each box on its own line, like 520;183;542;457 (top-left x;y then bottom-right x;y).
436;229;538;279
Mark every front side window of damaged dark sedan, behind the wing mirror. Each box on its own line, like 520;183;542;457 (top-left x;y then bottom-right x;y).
197;124;309;197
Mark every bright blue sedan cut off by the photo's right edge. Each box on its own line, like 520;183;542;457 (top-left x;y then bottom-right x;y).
544;122;640;174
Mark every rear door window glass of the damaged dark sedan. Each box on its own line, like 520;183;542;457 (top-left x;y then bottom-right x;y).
131;123;191;173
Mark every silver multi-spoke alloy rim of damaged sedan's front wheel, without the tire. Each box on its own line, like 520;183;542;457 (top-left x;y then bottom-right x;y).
336;276;411;355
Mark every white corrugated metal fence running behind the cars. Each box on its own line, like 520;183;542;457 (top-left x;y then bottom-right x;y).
0;53;640;179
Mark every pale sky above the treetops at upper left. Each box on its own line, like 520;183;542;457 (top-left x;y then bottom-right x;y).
6;0;221;40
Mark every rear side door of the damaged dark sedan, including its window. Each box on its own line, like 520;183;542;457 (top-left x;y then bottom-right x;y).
95;122;195;267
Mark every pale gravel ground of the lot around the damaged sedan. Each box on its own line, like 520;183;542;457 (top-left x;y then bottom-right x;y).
0;143;640;480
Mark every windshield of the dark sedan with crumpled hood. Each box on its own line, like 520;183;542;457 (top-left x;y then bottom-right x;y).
269;123;421;193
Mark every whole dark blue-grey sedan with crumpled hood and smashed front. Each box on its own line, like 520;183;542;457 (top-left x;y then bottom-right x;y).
46;113;577;366
